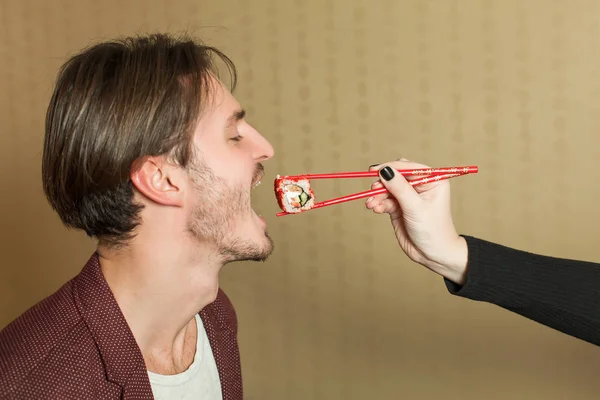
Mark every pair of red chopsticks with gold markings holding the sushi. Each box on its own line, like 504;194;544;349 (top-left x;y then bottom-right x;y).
277;165;479;217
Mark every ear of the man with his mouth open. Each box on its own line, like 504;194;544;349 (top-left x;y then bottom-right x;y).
130;157;183;207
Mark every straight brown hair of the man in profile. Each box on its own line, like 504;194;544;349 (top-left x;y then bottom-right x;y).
42;34;236;244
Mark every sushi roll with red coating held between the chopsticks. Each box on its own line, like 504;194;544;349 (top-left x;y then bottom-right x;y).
275;175;315;213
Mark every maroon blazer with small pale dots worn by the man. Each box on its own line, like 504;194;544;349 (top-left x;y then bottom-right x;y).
0;254;243;400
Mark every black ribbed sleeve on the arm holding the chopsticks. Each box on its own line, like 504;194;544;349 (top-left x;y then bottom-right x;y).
445;235;600;346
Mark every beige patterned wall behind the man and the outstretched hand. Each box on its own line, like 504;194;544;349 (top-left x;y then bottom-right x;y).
0;0;600;400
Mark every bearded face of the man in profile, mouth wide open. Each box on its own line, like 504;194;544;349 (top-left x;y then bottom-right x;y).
188;80;274;262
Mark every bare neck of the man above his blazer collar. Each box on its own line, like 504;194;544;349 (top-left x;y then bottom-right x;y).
98;234;223;370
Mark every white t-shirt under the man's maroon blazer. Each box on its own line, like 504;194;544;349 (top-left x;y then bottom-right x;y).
148;314;223;400
